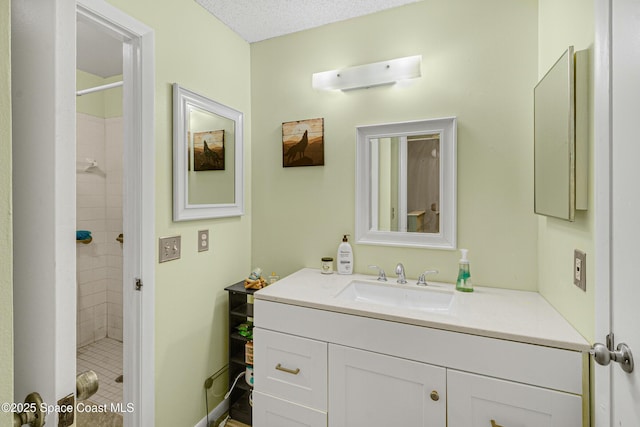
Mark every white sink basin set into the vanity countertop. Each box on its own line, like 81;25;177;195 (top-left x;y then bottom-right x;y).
335;280;453;313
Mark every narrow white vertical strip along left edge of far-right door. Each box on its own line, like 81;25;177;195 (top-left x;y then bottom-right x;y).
593;0;612;427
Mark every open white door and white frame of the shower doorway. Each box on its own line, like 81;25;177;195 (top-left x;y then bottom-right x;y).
12;0;155;426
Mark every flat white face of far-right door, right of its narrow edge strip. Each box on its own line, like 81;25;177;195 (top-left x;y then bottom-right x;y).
611;0;640;427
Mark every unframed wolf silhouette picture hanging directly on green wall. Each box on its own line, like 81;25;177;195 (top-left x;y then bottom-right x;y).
282;118;324;168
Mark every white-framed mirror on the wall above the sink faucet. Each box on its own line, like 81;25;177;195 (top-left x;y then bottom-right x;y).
356;117;457;249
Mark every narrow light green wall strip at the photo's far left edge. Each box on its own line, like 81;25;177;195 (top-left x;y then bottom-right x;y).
0;0;13;426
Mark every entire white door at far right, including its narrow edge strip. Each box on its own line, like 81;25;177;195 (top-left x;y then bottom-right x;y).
595;0;640;427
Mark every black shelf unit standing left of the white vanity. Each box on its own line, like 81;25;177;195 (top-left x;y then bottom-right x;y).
225;281;256;425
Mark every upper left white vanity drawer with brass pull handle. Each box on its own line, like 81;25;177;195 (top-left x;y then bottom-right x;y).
253;328;327;411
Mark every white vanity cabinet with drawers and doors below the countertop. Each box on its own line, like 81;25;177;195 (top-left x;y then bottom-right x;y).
253;299;589;427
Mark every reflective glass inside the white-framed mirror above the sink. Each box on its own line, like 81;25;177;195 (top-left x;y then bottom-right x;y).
371;134;440;233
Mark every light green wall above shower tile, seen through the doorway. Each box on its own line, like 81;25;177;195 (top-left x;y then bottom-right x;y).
76;70;122;119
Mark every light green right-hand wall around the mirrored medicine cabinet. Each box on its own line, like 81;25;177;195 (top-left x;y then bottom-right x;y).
538;0;595;342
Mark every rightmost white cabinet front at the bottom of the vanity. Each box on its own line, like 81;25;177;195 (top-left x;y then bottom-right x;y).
447;370;582;427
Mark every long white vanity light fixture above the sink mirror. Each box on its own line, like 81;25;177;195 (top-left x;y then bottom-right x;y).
311;55;422;90
